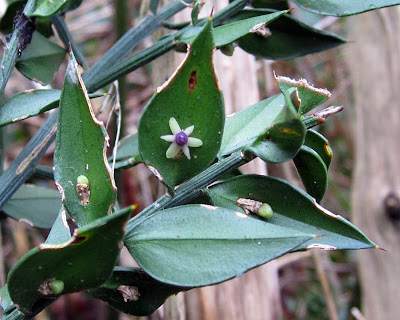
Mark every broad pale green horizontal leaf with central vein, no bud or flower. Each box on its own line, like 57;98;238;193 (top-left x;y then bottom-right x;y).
125;205;312;287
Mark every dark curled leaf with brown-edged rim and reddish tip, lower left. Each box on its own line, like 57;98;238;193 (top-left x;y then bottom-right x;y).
8;207;132;315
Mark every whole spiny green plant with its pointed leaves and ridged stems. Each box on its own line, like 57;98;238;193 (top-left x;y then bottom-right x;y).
0;0;397;319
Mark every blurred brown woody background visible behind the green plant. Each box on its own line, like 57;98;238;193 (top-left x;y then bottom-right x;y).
0;0;400;320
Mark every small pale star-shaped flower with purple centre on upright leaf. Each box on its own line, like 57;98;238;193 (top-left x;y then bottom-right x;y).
160;118;203;160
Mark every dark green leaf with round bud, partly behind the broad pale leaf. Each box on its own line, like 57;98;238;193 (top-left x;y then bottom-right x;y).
206;175;377;250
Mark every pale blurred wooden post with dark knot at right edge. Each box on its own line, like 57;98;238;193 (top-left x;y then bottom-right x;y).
347;7;400;320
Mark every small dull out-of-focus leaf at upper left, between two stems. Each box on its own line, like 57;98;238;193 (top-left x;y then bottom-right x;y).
15;32;65;84
